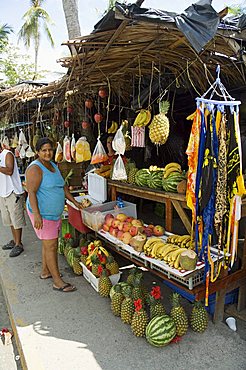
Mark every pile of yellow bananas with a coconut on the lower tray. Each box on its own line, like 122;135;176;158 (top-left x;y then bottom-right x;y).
143;235;197;271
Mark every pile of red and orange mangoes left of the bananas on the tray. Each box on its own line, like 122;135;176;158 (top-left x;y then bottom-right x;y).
102;213;165;248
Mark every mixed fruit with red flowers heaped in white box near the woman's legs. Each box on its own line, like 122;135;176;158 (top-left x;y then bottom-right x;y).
80;240;119;278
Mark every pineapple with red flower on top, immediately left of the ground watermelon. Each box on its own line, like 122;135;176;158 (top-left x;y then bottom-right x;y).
131;299;148;337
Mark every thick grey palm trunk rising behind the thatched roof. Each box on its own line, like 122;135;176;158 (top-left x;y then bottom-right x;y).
62;0;81;40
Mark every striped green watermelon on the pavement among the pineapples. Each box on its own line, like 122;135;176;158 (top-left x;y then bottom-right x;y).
145;315;176;347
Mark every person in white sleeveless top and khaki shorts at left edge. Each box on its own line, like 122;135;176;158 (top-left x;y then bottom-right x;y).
0;143;26;257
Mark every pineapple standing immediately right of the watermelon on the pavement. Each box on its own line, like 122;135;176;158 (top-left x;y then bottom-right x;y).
170;293;188;337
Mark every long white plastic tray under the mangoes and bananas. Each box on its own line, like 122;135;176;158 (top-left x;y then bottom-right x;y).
98;230;222;290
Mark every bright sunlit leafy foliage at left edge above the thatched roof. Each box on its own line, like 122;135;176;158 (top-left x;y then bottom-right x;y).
0;44;45;87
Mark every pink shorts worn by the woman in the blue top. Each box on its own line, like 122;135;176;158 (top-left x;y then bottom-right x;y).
27;209;61;240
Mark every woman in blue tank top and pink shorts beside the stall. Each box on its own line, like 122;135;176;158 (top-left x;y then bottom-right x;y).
26;137;81;293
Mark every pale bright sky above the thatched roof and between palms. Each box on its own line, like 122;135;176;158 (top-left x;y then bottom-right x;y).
0;0;234;72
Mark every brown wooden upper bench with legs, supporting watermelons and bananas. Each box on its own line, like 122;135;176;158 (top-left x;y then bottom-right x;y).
108;180;191;234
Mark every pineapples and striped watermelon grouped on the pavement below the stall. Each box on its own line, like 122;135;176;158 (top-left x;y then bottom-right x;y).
99;268;208;347
